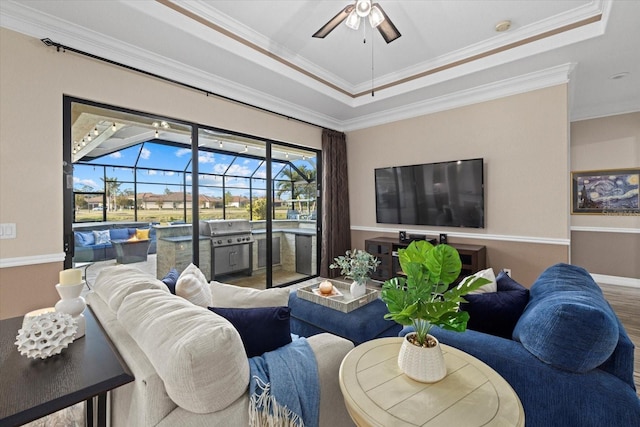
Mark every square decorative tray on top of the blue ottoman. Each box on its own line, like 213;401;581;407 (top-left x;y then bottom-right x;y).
296;278;378;313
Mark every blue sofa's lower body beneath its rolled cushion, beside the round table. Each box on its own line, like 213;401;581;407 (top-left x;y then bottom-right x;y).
424;327;640;427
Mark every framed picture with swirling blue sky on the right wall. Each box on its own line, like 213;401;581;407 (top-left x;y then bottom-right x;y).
571;168;640;215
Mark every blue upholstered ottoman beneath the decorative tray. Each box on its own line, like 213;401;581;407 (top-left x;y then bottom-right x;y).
289;291;402;345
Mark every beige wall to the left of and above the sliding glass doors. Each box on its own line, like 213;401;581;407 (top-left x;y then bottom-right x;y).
0;29;321;318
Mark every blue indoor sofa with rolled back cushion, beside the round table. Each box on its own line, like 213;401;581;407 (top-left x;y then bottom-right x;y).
400;264;640;427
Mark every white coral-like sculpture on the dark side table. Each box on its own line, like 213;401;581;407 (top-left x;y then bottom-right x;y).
15;312;78;359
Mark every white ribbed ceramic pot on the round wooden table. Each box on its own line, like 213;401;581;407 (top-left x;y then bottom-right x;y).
398;332;447;383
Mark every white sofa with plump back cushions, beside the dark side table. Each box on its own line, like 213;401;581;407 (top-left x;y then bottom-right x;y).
87;265;353;427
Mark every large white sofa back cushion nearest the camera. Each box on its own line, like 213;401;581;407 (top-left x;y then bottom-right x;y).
117;285;249;414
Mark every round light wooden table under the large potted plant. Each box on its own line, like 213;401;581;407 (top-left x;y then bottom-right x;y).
340;338;524;427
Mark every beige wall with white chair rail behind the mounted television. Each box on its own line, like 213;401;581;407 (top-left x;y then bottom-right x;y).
347;85;570;284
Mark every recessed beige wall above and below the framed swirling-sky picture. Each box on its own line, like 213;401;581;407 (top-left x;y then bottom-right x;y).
571;112;640;283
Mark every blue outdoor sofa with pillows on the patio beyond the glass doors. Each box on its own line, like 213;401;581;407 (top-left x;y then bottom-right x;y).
73;224;156;262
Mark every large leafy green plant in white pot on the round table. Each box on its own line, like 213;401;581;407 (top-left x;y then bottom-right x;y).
380;240;489;382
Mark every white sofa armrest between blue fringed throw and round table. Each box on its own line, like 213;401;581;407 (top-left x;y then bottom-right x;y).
307;333;353;427
